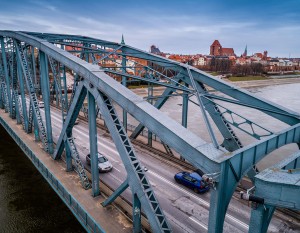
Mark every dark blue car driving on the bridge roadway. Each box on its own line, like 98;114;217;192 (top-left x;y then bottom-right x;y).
174;172;209;193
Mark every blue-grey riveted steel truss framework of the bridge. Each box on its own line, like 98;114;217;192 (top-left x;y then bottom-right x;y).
0;31;300;232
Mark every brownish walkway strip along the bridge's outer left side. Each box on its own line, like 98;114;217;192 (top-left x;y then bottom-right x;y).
0;109;132;232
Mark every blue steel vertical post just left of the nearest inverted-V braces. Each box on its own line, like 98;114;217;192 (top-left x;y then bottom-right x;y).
40;51;53;154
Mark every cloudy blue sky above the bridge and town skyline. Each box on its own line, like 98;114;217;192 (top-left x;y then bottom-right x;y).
0;0;300;58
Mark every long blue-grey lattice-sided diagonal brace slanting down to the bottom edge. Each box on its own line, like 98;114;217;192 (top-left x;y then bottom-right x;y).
85;84;171;233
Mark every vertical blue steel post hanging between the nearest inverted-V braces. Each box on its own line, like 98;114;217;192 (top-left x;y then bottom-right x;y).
88;92;100;197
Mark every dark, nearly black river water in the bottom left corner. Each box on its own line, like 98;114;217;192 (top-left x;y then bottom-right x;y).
0;125;85;233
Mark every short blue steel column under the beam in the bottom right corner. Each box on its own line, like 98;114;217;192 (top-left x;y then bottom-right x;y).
249;203;276;233
